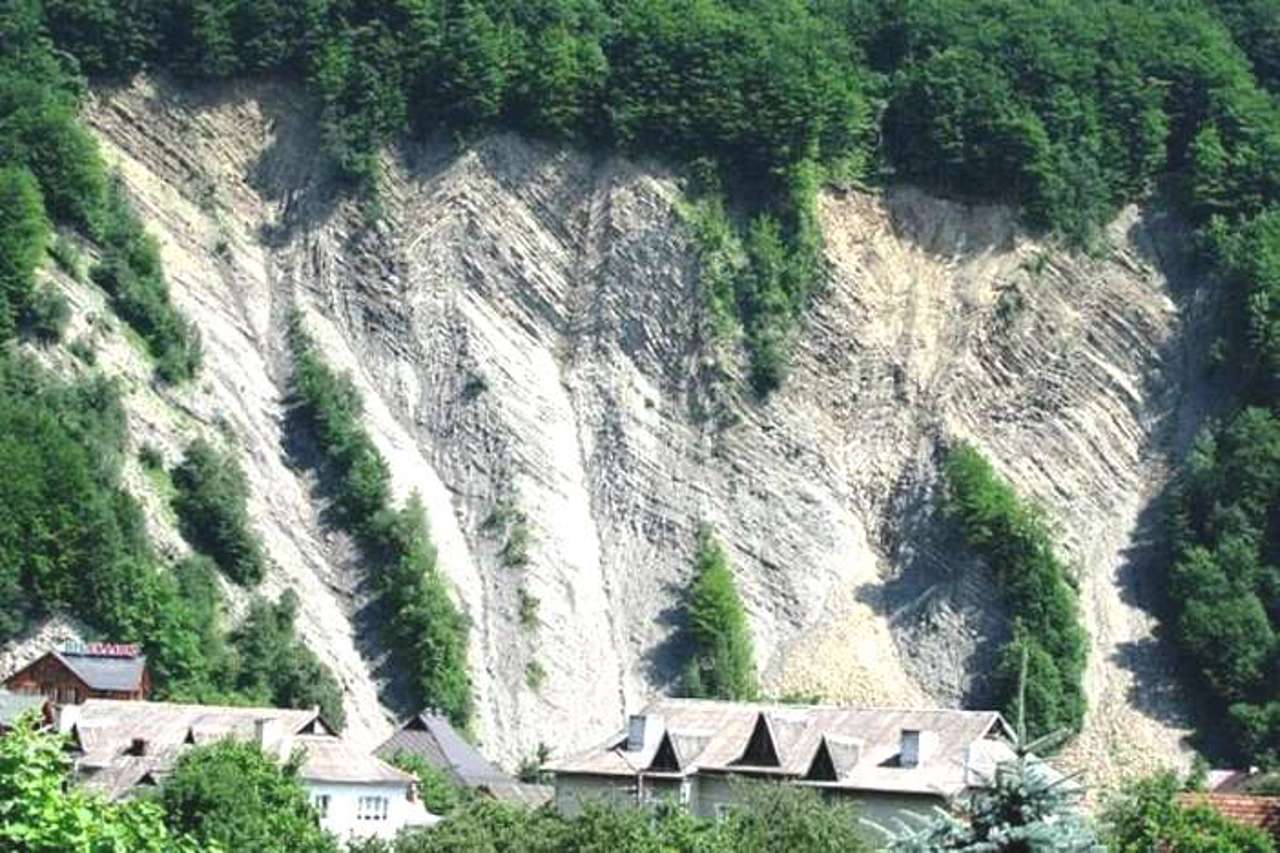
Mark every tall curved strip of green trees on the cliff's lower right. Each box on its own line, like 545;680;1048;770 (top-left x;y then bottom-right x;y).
943;444;1088;738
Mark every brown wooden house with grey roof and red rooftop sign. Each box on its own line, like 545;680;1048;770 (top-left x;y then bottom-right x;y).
4;643;151;704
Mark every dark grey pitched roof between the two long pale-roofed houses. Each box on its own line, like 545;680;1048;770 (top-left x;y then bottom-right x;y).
378;708;552;808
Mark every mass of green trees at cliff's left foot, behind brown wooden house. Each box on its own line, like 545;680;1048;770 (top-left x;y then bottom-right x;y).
0;356;343;725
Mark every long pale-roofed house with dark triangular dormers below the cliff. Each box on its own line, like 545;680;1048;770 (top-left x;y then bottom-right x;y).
545;699;1014;822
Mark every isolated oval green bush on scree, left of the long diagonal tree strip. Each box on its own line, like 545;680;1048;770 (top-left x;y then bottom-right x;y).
173;438;266;585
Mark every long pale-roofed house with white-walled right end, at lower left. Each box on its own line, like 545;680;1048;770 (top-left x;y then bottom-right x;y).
58;699;439;839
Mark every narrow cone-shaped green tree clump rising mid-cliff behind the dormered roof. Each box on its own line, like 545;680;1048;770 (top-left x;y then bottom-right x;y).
684;528;760;701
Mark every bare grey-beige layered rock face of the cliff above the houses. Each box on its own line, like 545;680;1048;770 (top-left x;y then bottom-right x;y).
64;76;1212;770
